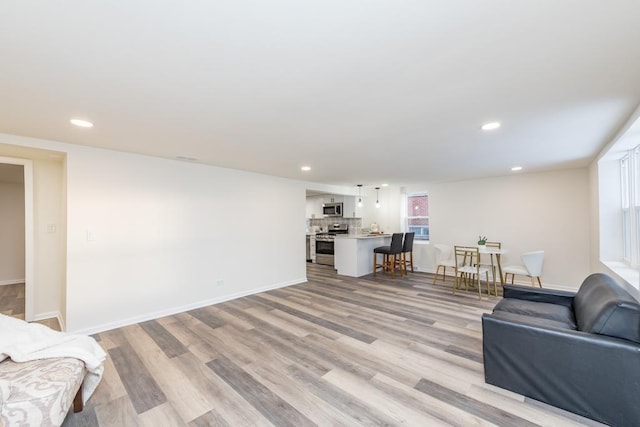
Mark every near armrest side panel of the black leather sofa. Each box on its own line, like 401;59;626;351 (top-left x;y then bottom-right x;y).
482;314;640;426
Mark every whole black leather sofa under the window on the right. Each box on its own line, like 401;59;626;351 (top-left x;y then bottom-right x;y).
482;273;640;426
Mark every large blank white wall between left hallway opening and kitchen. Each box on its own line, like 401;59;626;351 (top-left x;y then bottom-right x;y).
67;147;306;330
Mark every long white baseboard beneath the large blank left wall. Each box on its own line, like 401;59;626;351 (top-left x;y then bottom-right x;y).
72;277;307;335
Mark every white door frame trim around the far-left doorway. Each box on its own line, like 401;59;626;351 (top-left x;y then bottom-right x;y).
0;156;34;322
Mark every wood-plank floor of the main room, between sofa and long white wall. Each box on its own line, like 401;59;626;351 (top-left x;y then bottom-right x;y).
50;264;599;427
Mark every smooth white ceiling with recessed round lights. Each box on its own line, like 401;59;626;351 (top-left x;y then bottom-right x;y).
0;0;640;185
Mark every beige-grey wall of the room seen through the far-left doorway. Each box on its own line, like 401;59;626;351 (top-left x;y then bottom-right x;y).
0;182;25;285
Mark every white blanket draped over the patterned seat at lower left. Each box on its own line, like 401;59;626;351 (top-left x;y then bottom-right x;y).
0;314;107;403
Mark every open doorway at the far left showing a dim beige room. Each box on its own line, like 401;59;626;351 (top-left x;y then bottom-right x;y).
0;158;31;319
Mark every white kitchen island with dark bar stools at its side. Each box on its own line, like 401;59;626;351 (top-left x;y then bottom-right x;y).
334;234;391;277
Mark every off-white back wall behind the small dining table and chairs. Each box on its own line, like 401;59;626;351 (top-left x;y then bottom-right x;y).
408;168;590;289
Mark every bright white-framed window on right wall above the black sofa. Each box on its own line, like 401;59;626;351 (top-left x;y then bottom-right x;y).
620;146;640;266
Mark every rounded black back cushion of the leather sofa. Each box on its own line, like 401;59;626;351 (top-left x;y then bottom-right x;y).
573;273;640;343
